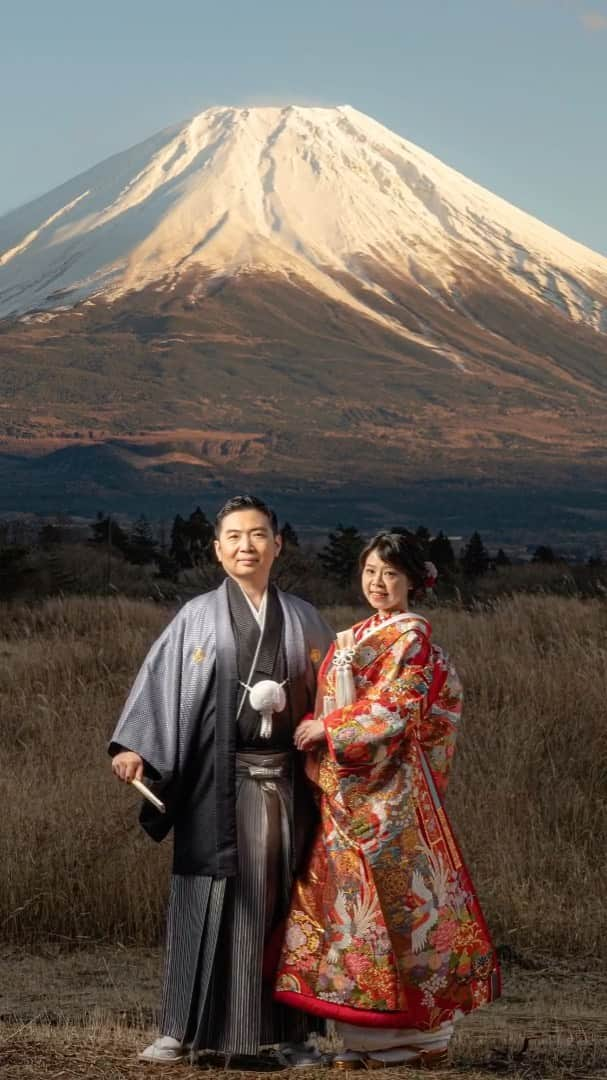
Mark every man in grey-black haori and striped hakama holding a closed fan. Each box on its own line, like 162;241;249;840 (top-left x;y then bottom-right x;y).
109;496;334;1067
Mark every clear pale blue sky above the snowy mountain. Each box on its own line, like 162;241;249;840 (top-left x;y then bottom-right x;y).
0;0;607;254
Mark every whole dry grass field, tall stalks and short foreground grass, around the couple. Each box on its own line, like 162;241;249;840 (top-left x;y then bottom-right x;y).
0;595;607;1080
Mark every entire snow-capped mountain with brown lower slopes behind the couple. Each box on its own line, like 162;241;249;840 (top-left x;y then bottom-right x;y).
0;106;607;529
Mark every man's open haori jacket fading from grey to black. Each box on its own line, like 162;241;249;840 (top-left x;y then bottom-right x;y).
109;582;334;877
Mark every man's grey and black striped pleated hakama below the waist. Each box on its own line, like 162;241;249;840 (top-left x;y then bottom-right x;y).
160;752;311;1054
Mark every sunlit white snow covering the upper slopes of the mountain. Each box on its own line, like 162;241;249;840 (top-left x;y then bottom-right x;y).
0;106;607;334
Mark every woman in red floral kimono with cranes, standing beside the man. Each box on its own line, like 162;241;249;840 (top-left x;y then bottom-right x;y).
275;532;500;1068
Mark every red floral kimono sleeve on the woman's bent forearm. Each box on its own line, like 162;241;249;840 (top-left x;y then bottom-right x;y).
324;626;432;768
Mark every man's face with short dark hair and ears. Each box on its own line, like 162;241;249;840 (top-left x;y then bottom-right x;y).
215;510;281;589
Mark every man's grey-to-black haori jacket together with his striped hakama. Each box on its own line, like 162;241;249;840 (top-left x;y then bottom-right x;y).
109;582;334;1054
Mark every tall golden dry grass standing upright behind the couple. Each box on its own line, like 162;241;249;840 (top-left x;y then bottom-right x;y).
0;596;607;958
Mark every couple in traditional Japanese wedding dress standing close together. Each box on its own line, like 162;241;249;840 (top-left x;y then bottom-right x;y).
110;496;499;1068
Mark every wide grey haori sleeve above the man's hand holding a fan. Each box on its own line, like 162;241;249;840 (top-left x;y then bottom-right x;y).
108;609;186;782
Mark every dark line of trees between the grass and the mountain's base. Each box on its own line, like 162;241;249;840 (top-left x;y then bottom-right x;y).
0;507;603;604
